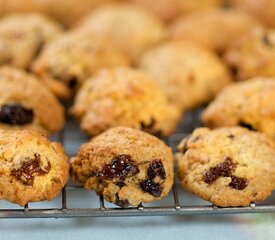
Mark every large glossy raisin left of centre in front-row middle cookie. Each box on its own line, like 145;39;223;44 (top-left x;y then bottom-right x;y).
96;154;139;180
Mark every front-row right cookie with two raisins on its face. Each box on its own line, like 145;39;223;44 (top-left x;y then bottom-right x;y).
176;127;275;207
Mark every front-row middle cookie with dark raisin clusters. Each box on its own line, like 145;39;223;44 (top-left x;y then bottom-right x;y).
71;127;174;207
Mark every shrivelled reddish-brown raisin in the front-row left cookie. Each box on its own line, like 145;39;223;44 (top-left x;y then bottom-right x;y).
11;154;51;185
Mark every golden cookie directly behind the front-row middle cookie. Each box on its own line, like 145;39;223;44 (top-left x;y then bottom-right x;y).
71;67;180;136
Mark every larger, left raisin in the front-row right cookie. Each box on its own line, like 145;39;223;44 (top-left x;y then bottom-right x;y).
204;157;235;184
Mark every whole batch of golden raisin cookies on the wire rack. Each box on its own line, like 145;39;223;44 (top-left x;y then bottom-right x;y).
0;0;275;208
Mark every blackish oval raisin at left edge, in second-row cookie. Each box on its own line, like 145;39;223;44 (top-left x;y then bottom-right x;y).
0;104;34;125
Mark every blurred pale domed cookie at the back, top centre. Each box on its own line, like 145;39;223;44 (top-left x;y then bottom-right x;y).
76;3;166;60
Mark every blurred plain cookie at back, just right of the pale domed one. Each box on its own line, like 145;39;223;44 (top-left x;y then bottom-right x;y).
170;8;259;53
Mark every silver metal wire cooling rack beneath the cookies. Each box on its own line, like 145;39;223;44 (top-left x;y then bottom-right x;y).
0;109;275;218
